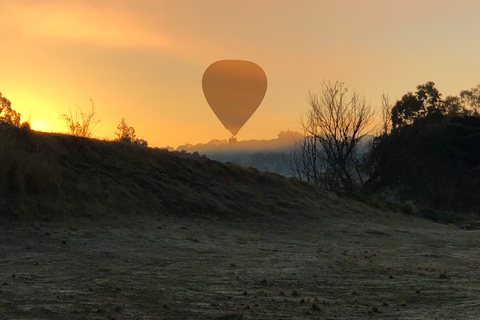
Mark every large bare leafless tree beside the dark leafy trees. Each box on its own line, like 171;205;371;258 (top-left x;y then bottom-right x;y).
293;81;374;191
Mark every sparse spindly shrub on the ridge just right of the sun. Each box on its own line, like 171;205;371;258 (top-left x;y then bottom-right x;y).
60;99;100;138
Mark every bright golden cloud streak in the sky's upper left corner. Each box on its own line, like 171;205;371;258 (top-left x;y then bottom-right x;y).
2;2;170;48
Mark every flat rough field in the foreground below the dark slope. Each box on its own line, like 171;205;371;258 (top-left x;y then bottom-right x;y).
0;206;480;319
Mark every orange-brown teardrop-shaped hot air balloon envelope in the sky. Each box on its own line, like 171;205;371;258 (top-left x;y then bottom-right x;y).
202;60;267;135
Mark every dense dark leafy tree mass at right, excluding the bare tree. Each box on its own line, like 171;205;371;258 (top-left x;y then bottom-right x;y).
363;82;480;213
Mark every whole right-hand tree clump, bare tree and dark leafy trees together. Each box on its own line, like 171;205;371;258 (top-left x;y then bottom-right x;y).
287;81;480;222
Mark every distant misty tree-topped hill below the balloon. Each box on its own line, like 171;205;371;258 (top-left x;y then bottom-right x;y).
177;131;302;176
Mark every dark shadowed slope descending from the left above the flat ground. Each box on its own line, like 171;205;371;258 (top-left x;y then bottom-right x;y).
0;125;332;222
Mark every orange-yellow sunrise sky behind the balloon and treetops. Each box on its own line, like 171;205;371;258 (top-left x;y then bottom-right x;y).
0;0;480;147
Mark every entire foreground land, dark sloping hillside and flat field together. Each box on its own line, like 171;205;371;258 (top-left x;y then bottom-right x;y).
0;126;480;320
